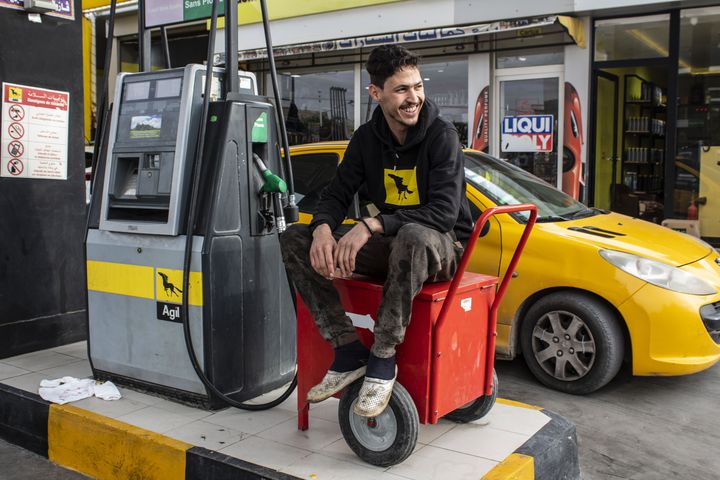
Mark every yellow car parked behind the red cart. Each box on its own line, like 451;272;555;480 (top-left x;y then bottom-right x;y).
290;142;720;394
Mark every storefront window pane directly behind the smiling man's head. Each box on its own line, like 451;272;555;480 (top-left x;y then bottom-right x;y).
360;59;468;145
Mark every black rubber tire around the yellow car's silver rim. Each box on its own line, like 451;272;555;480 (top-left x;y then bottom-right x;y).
520;291;625;395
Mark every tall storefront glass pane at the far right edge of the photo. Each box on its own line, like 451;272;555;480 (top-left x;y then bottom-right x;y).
673;7;720;232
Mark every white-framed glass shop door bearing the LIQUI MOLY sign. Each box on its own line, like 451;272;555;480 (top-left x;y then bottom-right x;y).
492;66;564;193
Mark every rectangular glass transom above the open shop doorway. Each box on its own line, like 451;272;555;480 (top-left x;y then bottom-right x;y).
595;14;670;62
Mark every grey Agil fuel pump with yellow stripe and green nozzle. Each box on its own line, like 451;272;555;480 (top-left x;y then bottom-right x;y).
86;0;297;409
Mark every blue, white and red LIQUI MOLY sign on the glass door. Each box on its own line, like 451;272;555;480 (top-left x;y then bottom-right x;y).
501;115;553;152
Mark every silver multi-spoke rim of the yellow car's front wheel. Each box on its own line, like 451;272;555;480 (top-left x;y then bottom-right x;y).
532;310;595;381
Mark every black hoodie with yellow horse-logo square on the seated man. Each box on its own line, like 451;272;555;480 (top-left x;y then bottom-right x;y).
310;99;473;240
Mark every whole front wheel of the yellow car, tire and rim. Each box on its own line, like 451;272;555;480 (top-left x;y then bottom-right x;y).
520;292;625;395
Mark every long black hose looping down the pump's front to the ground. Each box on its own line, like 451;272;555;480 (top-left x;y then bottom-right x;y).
180;0;297;410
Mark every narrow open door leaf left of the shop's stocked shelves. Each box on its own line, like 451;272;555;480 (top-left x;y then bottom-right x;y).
590;70;619;210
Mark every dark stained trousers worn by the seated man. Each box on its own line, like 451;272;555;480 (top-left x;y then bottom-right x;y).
280;224;463;358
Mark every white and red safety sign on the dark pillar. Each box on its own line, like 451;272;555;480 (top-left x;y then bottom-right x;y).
0;82;70;180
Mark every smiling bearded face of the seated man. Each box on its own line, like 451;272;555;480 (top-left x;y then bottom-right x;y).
368;67;425;144
